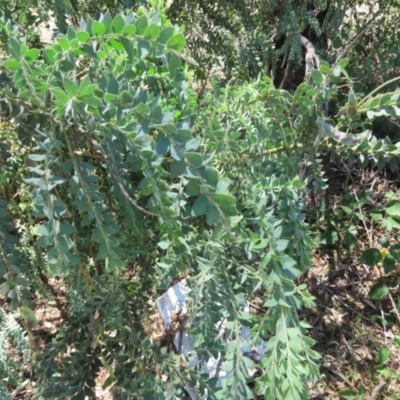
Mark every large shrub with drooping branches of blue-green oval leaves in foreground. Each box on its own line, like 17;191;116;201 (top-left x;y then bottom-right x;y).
0;1;400;399
